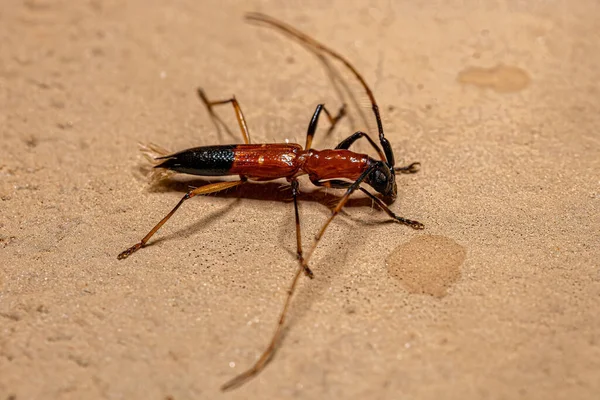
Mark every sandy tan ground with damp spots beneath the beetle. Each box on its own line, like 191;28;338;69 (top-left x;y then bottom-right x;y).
0;0;600;400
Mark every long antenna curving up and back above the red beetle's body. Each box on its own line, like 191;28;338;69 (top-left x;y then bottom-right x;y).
246;12;395;167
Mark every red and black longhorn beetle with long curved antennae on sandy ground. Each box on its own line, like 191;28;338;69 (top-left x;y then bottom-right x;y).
118;13;423;390
